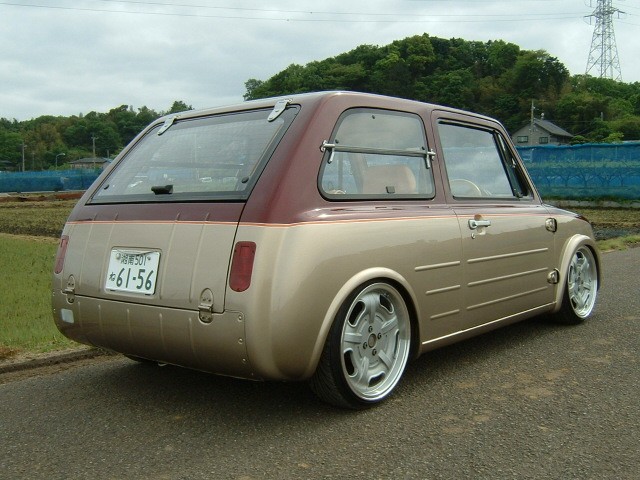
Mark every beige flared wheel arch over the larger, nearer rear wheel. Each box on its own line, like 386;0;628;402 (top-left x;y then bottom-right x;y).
304;267;420;378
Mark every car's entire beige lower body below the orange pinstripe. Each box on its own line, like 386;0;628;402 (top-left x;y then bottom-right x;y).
54;209;595;380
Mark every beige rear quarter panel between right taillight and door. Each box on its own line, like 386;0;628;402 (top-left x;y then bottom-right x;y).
227;208;462;379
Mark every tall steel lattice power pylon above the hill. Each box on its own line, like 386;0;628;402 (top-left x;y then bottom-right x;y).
585;0;624;81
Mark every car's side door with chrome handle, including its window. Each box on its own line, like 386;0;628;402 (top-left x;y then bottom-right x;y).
436;115;555;327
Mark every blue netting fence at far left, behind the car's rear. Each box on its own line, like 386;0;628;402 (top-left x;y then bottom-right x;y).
0;168;102;193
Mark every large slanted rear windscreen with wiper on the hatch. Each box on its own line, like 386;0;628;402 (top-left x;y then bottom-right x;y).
91;108;296;203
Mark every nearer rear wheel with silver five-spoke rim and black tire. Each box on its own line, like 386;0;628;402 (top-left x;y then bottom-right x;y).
310;281;411;409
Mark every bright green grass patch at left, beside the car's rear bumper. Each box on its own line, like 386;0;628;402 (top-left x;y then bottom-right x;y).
0;233;75;358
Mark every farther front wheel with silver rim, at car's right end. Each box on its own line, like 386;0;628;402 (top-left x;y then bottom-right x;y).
554;246;598;325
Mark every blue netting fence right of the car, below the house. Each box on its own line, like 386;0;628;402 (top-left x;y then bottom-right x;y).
518;142;640;199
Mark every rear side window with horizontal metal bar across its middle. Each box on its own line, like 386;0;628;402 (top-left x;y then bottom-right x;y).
319;109;434;200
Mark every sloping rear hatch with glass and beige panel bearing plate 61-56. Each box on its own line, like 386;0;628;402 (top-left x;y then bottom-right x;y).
64;107;297;312
